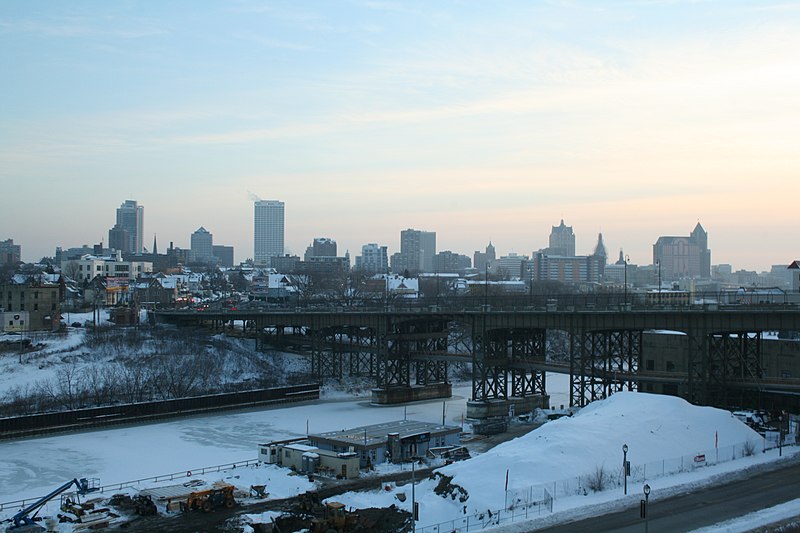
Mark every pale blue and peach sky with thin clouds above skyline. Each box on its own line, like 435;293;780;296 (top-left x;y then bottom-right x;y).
0;0;800;270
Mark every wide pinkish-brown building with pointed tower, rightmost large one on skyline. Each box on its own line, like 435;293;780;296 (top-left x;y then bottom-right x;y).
653;222;711;281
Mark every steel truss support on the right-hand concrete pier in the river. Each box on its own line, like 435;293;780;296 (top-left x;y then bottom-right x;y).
472;328;546;401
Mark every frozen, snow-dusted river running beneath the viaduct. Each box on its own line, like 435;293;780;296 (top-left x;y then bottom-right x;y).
0;374;569;502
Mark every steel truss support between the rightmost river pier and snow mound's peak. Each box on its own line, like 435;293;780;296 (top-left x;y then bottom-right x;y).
569;330;642;407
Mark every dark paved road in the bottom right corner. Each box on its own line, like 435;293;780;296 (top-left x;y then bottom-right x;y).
535;457;800;533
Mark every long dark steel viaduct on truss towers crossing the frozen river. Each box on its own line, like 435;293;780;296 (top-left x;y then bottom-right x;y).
154;306;800;418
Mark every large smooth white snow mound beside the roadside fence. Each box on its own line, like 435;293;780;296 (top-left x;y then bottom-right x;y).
439;392;762;509
